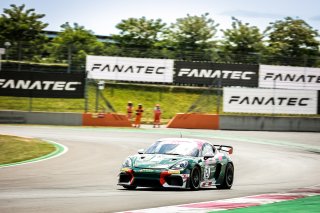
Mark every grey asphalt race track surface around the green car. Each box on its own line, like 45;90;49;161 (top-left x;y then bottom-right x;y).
0;125;320;213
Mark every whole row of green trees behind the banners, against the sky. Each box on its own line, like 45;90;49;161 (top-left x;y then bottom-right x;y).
0;4;320;70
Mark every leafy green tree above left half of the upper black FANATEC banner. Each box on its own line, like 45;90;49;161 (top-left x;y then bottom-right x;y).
169;13;219;60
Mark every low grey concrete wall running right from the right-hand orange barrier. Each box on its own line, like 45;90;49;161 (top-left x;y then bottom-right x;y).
220;115;320;132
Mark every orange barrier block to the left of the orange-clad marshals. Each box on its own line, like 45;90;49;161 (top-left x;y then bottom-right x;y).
82;113;132;127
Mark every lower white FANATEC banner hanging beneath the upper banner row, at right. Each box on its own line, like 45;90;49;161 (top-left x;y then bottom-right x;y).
223;87;318;114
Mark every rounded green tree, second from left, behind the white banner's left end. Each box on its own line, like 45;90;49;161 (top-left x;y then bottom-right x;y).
48;22;104;70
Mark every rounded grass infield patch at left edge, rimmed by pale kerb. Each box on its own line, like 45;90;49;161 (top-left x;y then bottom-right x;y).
0;135;63;167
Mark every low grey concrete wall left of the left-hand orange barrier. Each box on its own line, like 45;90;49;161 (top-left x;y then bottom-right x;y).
0;111;82;126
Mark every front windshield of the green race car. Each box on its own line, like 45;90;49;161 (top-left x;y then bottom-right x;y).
145;141;199;157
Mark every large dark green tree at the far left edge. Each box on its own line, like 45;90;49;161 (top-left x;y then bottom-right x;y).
0;4;48;60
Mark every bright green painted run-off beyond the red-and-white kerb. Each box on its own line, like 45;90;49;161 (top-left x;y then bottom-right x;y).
210;196;320;213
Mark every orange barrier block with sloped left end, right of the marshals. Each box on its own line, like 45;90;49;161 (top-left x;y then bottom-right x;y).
167;113;219;129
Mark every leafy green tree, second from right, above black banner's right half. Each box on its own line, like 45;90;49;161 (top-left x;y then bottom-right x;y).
221;17;265;63
